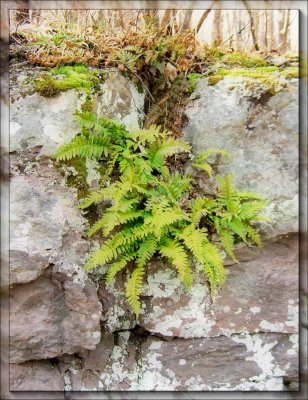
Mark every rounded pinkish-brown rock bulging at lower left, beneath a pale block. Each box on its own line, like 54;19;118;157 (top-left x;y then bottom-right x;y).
10;276;101;363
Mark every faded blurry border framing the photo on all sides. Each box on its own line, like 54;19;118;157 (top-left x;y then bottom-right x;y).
1;0;308;400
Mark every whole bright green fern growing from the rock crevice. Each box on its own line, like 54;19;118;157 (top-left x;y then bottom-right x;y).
55;113;266;316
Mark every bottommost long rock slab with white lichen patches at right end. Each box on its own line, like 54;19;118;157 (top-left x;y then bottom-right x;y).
85;332;298;391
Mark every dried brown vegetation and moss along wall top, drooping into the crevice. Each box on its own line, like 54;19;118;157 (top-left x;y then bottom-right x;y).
11;13;298;135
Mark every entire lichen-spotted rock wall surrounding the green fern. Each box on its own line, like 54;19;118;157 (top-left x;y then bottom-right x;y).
10;71;298;391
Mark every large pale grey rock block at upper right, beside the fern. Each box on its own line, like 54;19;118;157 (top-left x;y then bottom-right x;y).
185;77;299;237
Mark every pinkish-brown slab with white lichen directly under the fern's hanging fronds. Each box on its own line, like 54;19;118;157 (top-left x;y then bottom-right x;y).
99;235;299;338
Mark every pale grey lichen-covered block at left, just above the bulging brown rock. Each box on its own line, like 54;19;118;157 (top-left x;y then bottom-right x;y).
10;172;89;285
